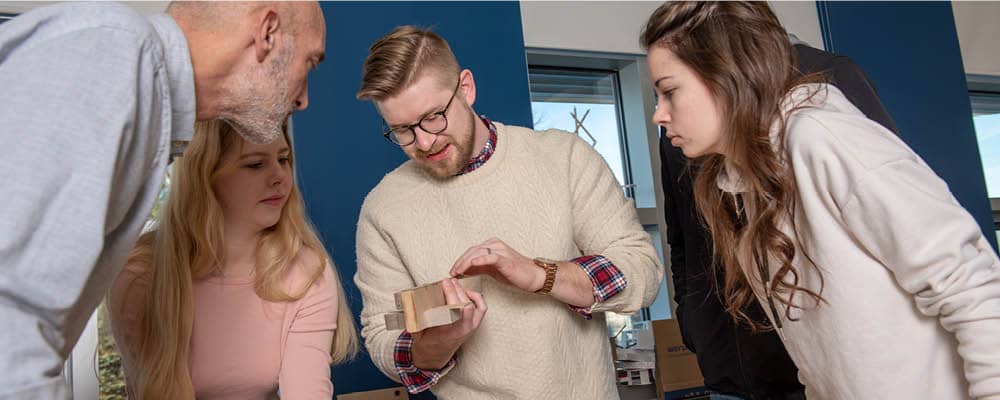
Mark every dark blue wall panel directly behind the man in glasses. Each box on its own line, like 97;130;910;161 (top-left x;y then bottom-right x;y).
294;2;531;398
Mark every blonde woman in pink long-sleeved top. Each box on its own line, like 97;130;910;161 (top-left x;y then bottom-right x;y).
108;121;358;400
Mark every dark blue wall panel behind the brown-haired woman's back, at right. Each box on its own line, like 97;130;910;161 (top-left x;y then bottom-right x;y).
817;1;997;250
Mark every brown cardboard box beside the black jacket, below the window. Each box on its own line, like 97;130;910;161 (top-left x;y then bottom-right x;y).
653;319;705;394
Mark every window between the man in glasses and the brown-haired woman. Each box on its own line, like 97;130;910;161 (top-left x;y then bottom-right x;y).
527;49;672;324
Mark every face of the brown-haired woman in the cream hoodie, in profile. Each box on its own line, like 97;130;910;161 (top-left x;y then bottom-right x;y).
647;46;722;157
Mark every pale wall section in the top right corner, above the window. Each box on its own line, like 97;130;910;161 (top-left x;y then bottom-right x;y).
952;1;1000;76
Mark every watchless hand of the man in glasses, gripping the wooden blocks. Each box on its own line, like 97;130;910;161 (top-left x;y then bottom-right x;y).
410;278;486;371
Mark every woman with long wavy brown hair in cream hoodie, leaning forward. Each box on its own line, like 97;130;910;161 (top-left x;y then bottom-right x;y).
641;2;1000;399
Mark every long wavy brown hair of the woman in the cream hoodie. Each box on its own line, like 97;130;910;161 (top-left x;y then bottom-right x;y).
640;1;823;330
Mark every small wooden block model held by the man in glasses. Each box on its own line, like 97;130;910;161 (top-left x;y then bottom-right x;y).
385;278;478;333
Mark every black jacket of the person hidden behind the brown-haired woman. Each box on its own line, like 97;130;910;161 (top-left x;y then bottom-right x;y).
660;45;897;399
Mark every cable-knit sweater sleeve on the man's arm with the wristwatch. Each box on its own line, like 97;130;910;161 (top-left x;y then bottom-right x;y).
569;138;663;314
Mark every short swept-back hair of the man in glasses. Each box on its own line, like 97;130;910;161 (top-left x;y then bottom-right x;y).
357;25;459;101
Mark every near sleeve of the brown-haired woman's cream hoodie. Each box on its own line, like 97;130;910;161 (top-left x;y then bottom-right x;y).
842;159;1000;399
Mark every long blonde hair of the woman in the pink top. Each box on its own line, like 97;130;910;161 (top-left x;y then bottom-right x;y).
128;121;358;399
